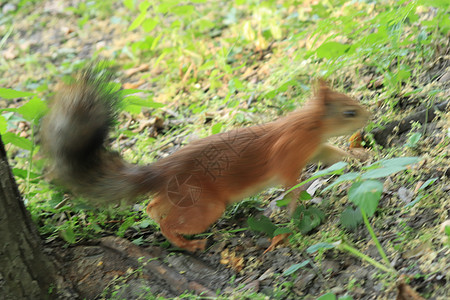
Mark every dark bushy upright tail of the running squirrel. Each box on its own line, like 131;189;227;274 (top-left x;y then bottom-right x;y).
41;64;163;202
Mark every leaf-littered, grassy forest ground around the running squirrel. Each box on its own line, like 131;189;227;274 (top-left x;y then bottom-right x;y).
0;0;450;299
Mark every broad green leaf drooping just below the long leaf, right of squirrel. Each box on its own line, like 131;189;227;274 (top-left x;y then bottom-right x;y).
348;180;383;217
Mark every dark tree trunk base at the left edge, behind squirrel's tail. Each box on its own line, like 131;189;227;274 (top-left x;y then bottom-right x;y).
0;137;56;300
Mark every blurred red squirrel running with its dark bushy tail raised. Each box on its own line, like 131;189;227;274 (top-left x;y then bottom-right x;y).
40;66;369;252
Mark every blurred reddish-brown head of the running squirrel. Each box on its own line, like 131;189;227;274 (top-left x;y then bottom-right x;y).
313;79;369;138
